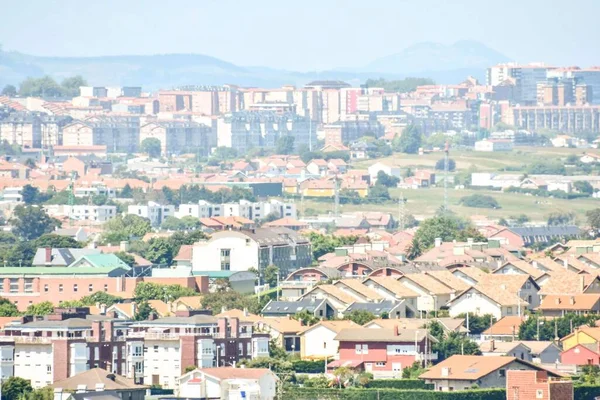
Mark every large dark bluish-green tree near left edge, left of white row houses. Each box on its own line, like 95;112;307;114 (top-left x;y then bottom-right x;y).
9;205;60;240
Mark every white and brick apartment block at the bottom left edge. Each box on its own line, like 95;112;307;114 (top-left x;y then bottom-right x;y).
0;307;127;388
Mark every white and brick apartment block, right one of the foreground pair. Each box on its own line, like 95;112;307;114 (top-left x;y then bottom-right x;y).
124;310;269;389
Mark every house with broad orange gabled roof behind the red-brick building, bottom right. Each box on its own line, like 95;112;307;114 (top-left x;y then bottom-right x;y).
419;355;560;391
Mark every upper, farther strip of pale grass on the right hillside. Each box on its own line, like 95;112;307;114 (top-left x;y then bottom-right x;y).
352;147;582;172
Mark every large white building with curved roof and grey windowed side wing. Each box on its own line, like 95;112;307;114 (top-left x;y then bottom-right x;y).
192;228;312;276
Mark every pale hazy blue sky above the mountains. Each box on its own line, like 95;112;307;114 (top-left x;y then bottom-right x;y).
0;0;600;70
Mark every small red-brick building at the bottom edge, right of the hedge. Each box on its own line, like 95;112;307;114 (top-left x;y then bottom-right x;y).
506;369;575;400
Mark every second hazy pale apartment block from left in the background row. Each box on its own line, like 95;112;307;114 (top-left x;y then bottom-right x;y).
62;115;140;153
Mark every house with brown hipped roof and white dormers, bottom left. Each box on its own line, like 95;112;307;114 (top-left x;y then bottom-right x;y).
50;368;147;400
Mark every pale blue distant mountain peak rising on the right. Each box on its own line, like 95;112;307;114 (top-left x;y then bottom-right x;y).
363;40;509;76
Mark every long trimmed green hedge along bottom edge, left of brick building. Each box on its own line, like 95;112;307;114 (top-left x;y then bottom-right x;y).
284;388;506;400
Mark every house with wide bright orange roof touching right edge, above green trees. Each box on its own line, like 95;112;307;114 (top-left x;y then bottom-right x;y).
538;294;600;317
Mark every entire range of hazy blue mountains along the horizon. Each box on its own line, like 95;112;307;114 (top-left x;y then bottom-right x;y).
0;41;508;90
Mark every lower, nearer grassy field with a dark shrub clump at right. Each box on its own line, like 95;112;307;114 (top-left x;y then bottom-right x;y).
299;188;600;222
